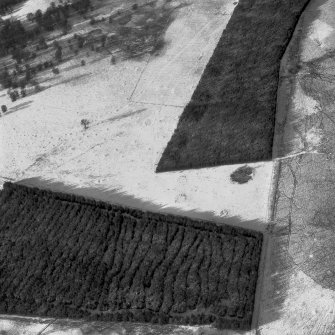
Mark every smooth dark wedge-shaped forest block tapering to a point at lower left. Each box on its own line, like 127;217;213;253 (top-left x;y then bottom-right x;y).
157;0;309;172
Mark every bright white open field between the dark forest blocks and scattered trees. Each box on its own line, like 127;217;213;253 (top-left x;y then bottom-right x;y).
0;0;272;227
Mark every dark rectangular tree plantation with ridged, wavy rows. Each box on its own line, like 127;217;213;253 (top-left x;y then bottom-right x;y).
0;183;262;329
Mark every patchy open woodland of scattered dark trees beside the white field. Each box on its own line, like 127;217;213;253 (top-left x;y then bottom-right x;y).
0;0;185;101
